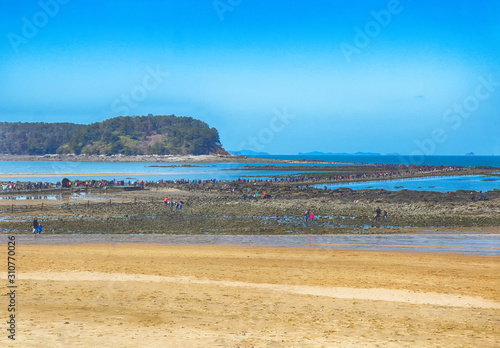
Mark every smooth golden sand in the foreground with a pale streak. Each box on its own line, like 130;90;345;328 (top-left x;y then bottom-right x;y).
0;245;500;347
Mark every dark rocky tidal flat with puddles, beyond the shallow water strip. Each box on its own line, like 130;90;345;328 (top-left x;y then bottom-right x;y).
0;178;500;234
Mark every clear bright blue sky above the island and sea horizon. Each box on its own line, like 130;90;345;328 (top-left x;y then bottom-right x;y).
0;0;500;155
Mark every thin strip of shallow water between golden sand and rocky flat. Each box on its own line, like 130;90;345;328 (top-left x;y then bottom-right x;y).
0;233;500;256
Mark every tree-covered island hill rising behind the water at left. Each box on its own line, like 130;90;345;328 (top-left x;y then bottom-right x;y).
0;114;227;156
